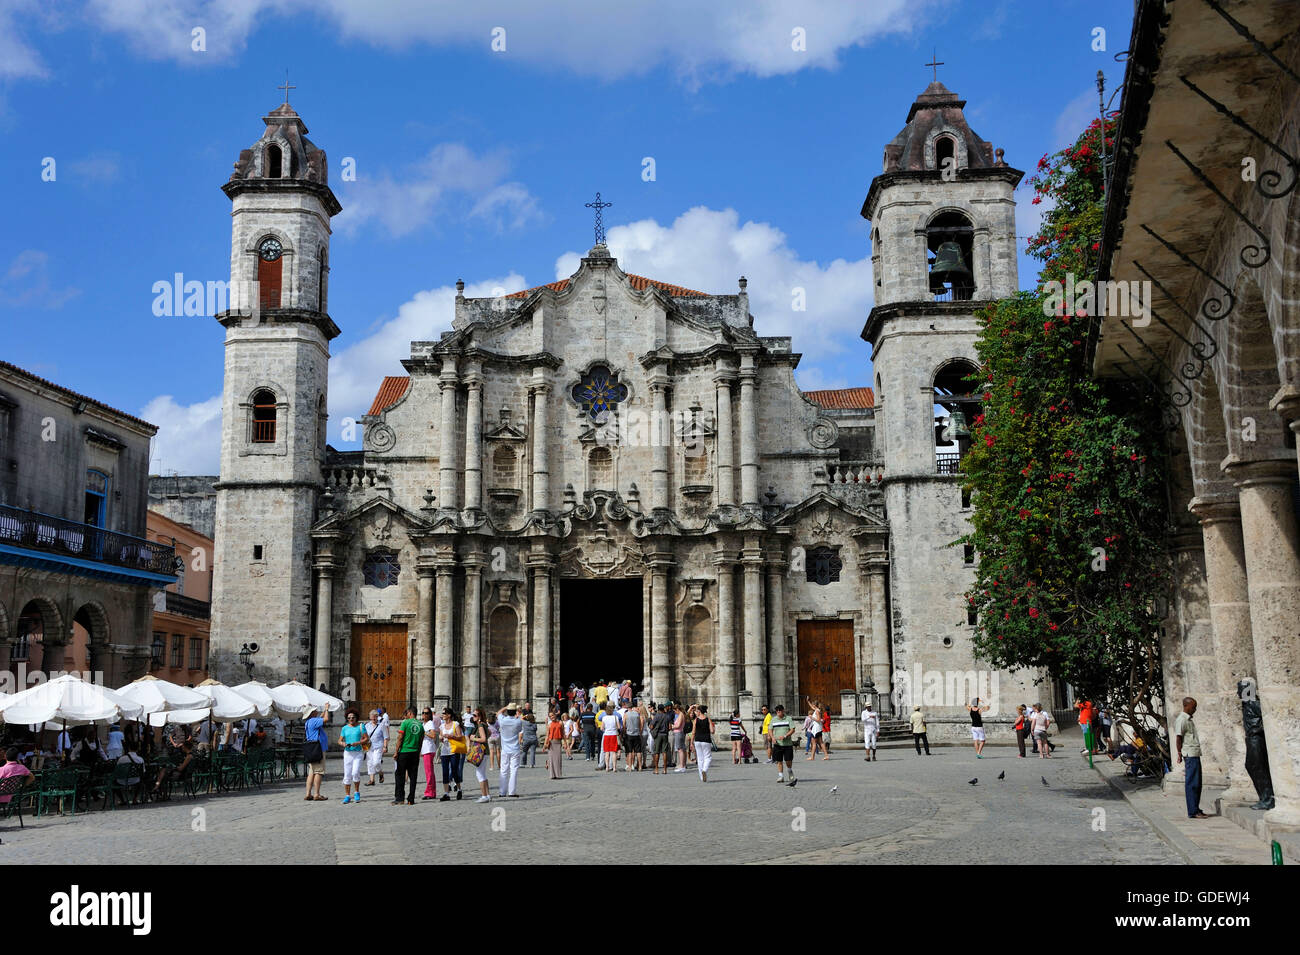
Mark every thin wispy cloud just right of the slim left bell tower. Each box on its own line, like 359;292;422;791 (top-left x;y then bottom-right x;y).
337;143;542;238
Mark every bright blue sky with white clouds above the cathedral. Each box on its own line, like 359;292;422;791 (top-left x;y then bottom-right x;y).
0;0;1132;473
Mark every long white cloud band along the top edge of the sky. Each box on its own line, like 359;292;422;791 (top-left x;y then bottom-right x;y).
71;0;939;83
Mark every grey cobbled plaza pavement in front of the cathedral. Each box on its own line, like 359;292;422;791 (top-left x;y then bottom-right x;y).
0;747;1182;864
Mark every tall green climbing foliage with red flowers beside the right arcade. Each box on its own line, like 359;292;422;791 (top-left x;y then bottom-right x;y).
962;111;1170;738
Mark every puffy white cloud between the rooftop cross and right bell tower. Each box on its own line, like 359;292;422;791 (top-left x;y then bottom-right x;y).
555;207;872;388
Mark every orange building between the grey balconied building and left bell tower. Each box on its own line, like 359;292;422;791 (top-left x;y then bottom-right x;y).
147;509;212;686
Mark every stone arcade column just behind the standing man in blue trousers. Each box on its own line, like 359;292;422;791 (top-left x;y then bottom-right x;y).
1166;531;1227;786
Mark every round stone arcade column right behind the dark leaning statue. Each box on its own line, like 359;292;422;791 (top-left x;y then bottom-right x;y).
1187;498;1258;803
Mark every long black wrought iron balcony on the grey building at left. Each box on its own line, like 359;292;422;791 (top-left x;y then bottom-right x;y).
0;504;176;577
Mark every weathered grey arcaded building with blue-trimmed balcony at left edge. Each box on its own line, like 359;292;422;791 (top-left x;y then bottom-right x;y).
0;361;176;691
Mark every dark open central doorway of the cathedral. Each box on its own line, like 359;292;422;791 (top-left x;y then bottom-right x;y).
560;577;645;689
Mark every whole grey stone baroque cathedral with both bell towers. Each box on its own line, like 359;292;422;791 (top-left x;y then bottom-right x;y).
211;83;1035;735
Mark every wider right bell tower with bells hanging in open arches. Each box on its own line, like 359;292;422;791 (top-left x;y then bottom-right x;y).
862;79;1027;738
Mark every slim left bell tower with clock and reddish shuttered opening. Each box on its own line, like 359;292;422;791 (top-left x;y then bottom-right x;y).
208;99;342;683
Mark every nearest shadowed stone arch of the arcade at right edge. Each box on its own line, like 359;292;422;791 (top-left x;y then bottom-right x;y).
1221;272;1295;461
